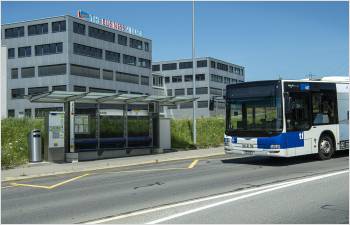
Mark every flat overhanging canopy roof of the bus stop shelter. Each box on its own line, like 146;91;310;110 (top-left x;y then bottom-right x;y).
25;91;198;106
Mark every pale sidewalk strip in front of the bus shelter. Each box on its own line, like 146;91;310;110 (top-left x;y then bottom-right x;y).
1;146;224;182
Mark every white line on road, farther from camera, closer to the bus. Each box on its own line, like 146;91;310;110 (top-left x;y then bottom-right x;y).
86;170;349;224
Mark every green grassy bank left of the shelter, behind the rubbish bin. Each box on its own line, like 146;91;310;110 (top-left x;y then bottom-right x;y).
1;118;45;168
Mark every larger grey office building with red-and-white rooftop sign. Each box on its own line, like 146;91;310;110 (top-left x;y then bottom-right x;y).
1;11;152;117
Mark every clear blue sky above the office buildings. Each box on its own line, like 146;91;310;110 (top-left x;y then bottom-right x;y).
1;1;349;81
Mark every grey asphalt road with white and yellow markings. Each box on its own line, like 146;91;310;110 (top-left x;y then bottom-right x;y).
1;152;349;223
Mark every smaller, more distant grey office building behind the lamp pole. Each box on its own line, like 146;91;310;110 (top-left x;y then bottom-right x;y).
152;57;245;118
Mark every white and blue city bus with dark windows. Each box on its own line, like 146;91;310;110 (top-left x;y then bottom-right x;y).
224;77;349;160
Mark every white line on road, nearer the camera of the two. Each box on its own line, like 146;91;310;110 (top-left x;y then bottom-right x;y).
146;170;349;224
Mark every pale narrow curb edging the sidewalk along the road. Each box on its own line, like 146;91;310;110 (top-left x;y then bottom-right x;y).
1;153;225;183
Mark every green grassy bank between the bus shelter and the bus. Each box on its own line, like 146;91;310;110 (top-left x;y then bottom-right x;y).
171;117;225;149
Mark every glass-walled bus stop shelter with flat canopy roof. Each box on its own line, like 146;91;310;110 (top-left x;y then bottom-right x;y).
27;91;195;162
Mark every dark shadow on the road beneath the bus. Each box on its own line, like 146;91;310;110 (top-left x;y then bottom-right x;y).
221;150;349;166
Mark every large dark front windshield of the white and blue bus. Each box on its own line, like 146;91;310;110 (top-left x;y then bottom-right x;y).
226;83;283;137
